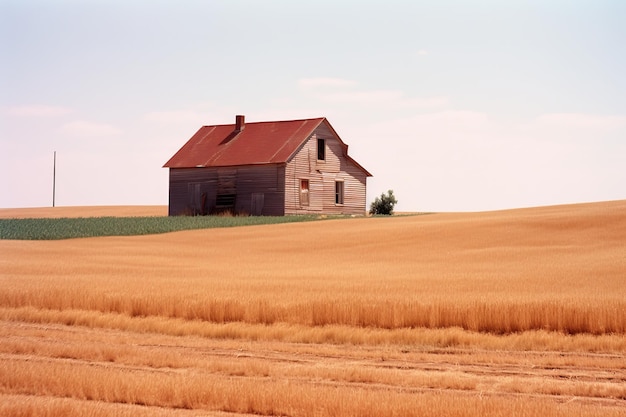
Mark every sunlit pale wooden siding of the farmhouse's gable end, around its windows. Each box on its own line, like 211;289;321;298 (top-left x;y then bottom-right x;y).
285;123;367;214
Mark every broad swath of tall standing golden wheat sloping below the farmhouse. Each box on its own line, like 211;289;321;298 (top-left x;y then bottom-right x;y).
0;203;626;334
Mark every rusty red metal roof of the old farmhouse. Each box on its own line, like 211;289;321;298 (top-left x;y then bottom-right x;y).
164;117;371;176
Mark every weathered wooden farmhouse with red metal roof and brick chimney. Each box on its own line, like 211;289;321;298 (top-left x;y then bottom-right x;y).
164;116;371;216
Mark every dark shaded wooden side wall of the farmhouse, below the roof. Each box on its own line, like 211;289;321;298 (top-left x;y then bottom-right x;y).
169;165;285;216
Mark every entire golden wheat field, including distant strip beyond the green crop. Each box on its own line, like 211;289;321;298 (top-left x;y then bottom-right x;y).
0;201;626;417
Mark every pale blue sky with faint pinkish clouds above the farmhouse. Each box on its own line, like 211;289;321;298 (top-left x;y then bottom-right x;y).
0;0;626;211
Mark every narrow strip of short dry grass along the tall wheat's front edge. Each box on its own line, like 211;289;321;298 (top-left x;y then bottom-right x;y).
0;307;626;352
